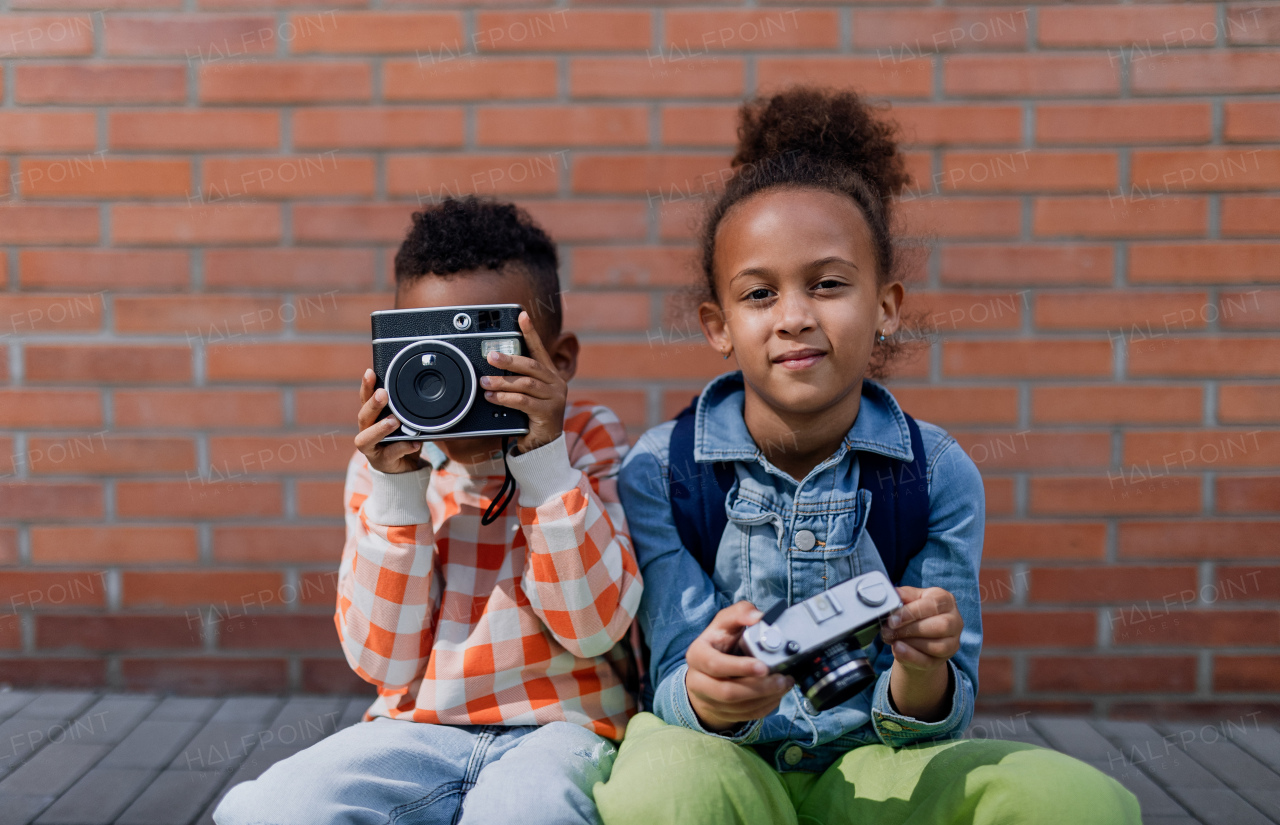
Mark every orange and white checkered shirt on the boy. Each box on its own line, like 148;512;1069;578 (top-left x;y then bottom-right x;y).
334;403;641;739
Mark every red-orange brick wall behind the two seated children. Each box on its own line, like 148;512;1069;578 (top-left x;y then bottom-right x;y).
0;0;1280;715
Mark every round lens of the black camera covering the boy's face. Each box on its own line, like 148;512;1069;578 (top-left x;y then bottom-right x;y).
387;339;476;432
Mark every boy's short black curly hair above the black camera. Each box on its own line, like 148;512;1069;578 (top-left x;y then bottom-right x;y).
396;194;563;335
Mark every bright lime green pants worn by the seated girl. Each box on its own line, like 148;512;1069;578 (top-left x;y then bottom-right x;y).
595;714;1142;825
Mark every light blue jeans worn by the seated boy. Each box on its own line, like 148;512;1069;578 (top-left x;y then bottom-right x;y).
214;716;617;825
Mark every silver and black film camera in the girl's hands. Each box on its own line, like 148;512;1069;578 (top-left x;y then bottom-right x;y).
741;570;902;711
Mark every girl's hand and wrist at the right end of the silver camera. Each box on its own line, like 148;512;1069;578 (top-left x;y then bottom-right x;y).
881;587;964;721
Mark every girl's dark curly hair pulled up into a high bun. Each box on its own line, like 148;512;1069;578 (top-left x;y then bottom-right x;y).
700;86;911;377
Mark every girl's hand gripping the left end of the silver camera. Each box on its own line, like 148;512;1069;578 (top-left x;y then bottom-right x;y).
685;601;795;732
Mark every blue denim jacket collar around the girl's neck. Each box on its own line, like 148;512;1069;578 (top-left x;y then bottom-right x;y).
694;370;914;462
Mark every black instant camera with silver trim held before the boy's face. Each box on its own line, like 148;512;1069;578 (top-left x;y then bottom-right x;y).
370;303;529;443
